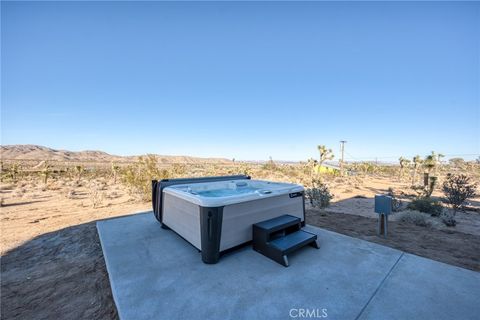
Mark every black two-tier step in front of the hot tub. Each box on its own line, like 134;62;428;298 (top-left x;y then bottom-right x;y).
253;215;320;267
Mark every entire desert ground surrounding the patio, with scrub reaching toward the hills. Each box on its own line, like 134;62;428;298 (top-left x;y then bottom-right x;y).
0;146;480;319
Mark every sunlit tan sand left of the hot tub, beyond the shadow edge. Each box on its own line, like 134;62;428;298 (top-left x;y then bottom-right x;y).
0;182;151;255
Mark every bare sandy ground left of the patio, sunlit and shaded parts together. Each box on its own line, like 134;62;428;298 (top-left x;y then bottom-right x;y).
0;181;151;319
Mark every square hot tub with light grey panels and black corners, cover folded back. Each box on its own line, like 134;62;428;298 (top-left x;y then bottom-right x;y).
152;176;305;263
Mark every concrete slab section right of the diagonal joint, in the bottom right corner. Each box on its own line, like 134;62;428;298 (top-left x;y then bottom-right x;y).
361;254;480;320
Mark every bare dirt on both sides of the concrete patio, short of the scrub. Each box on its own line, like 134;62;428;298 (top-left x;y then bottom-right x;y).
0;178;480;319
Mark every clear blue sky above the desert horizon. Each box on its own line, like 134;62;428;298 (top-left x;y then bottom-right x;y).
1;1;480;161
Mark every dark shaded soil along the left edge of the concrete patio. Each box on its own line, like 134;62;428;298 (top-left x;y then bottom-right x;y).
1;222;118;319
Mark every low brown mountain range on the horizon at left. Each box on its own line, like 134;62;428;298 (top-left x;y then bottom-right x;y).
0;144;231;163
